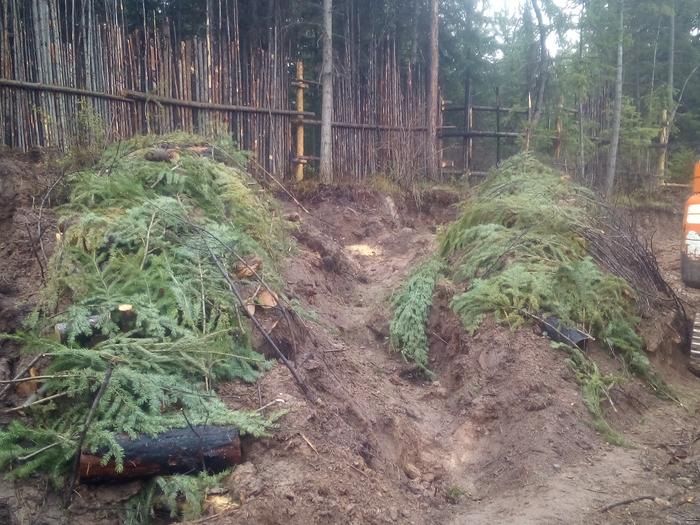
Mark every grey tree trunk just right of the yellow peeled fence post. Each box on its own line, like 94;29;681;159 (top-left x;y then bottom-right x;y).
320;0;333;184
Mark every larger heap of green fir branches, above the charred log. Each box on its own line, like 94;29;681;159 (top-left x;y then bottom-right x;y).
0;135;286;516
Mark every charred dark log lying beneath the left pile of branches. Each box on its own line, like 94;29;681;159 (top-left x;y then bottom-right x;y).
80;426;241;482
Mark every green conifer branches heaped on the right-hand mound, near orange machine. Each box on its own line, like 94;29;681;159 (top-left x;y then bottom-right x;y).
392;150;681;388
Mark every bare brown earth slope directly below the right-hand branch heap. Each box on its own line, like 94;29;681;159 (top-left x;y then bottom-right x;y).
429;290;599;499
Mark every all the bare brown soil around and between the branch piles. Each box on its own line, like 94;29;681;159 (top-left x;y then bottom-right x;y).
0;149;700;525
